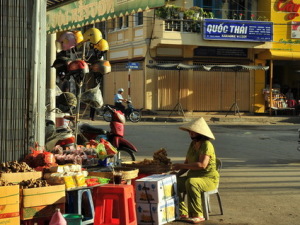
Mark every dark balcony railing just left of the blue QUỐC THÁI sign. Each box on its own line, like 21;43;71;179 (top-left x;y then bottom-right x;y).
165;19;202;33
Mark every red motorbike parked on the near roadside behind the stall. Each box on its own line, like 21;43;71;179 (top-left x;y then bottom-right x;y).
68;106;138;165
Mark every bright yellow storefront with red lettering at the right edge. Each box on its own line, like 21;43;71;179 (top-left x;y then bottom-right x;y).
258;0;300;113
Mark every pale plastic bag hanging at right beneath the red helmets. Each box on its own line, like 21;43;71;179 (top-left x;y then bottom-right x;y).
81;84;103;108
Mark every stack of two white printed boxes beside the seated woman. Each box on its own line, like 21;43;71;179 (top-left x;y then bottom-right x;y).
135;174;179;225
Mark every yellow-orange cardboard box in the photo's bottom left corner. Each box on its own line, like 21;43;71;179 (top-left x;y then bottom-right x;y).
0;185;20;221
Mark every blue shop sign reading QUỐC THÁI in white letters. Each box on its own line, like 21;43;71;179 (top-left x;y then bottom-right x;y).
203;19;273;42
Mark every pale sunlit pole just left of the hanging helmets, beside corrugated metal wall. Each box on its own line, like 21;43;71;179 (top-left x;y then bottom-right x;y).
46;34;56;122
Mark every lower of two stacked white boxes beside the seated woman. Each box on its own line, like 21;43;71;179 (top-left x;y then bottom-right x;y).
136;197;179;225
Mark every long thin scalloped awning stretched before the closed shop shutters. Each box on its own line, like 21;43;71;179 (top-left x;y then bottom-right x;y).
147;63;269;71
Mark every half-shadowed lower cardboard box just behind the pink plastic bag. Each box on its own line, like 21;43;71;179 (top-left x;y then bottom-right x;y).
20;203;65;219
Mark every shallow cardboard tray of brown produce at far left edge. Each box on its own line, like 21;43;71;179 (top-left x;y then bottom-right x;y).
0;171;42;183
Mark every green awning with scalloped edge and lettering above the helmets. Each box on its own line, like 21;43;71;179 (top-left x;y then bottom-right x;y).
47;0;165;34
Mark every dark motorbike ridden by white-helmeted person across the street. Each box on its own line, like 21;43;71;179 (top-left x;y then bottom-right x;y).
103;100;142;123
